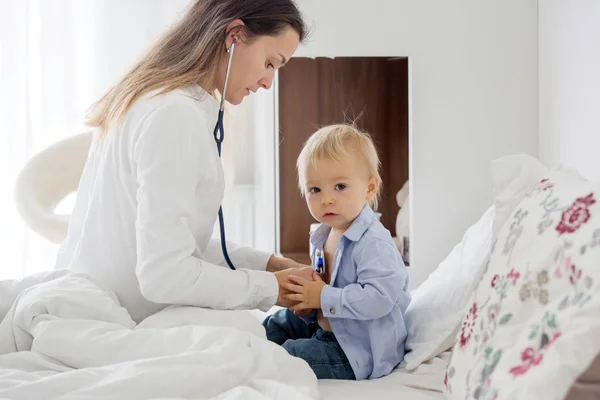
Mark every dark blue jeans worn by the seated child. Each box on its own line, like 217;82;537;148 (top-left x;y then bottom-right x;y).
263;309;356;380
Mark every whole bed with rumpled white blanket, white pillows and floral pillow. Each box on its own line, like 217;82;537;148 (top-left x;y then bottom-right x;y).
5;155;600;400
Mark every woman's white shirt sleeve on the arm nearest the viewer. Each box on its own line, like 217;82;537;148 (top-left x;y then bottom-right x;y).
134;102;278;311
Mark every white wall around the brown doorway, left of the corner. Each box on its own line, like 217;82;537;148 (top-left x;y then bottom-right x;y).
296;0;538;287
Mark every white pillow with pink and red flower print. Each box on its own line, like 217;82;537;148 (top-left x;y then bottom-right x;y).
444;169;600;399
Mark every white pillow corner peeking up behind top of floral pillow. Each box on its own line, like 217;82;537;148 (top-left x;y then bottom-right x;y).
492;154;549;238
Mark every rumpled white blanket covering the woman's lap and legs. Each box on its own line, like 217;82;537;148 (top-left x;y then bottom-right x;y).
0;274;319;400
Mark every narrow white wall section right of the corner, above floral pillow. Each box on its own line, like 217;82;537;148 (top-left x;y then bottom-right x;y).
539;0;600;181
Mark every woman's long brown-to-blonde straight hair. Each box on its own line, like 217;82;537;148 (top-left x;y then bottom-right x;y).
86;0;306;134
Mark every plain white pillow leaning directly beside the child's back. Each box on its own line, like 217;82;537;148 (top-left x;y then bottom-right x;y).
404;207;494;370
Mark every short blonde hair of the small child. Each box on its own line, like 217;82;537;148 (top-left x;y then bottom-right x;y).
296;124;382;210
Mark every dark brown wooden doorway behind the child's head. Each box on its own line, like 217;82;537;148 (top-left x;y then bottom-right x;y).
278;57;409;264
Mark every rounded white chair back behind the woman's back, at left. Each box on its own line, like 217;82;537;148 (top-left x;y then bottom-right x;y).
15;132;92;244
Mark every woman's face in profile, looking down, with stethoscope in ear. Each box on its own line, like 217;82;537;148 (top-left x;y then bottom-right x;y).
217;23;300;105
